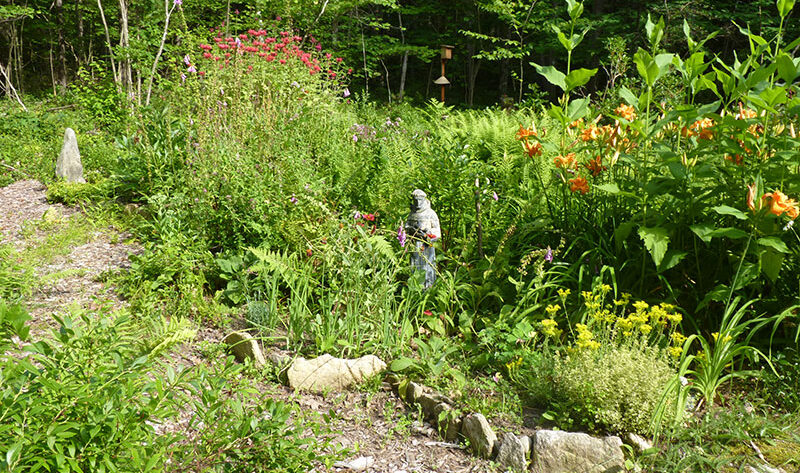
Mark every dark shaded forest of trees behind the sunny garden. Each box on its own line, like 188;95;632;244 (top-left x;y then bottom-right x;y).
0;0;800;106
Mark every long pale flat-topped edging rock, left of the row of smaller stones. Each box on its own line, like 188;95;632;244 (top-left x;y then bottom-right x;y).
286;354;386;392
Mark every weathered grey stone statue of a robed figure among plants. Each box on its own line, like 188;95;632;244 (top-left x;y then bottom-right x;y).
405;189;442;288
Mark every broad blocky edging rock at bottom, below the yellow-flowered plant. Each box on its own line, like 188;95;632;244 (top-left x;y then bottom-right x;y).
531;430;625;473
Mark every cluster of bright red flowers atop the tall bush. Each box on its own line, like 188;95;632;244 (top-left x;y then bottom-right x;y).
200;29;352;79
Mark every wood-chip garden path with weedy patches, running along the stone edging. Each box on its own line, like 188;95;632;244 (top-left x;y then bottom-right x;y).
0;181;493;473
